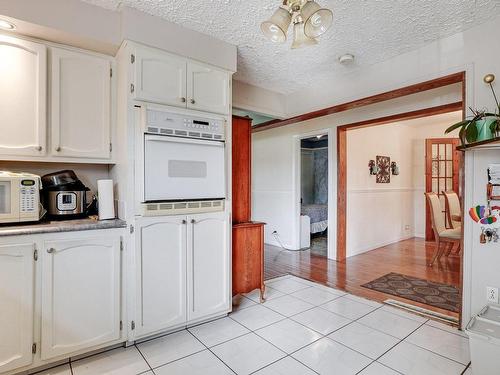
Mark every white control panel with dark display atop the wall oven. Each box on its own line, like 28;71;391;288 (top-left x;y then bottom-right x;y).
144;108;225;141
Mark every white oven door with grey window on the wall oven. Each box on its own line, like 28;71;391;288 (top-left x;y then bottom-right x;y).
144;134;226;202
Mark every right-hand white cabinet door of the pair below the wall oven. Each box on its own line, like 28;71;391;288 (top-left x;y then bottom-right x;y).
187;212;231;321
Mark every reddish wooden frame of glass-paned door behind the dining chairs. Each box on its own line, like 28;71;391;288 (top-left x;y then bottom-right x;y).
425;138;463;241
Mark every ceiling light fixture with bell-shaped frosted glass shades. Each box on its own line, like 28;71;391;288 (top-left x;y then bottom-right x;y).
260;0;333;49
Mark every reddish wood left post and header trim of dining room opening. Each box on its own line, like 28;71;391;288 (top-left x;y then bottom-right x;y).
337;102;463;262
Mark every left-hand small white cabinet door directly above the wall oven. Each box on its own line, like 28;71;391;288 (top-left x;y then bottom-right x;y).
132;47;186;107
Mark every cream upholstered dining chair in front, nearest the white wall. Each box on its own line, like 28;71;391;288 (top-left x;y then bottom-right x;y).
425;193;462;267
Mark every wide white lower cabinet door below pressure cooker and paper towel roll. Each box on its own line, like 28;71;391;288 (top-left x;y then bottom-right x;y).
41;234;121;359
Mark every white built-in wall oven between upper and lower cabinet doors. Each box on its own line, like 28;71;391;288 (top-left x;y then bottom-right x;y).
141;106;226;215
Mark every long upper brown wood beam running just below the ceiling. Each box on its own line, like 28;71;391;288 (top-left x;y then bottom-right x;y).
252;72;465;132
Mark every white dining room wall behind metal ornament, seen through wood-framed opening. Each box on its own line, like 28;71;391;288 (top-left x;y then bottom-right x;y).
347;111;462;257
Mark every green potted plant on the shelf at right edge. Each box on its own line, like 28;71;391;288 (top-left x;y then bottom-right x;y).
445;74;500;145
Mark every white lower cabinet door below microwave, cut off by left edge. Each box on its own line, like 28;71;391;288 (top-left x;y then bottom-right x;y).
0;242;35;373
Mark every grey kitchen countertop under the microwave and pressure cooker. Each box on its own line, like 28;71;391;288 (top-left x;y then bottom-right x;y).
0;217;127;237
